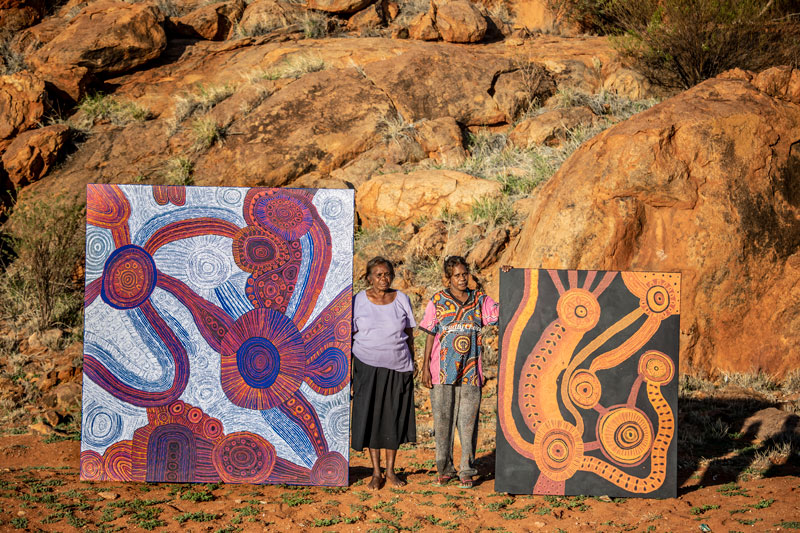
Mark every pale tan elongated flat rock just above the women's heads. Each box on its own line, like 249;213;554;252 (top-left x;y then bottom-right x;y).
356;170;502;227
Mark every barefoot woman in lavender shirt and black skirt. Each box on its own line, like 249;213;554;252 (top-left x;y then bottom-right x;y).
351;257;417;490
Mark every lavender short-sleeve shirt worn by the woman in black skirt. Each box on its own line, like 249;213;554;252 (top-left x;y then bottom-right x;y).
353;291;417;372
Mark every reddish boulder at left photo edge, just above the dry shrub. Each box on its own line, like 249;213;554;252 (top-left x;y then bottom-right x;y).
3;124;70;186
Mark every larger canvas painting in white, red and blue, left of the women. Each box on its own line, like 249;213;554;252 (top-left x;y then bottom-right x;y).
81;185;353;485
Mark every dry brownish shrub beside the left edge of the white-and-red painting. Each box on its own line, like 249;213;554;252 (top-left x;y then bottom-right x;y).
0;196;85;329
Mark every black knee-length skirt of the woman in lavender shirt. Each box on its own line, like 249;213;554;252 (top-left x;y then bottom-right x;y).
350;356;417;450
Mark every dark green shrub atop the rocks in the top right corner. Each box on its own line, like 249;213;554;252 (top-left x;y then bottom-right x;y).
548;0;800;89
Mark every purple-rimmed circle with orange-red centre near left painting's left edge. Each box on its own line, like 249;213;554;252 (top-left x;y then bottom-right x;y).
100;244;156;309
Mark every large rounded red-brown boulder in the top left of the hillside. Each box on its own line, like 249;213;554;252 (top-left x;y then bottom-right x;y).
29;0;167;100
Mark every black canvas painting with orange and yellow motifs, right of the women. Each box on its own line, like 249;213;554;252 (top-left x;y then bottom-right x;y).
495;269;680;498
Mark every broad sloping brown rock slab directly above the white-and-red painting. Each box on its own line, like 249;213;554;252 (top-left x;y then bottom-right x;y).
196;68;392;186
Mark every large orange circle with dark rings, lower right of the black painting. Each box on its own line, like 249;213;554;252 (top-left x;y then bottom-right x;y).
597;407;653;465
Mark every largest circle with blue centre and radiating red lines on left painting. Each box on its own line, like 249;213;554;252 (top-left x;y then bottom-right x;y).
220;309;307;410
